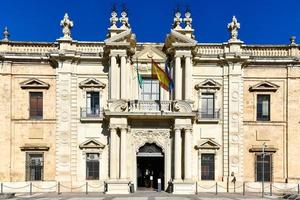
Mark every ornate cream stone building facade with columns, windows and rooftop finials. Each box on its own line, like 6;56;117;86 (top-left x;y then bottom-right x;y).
0;12;300;194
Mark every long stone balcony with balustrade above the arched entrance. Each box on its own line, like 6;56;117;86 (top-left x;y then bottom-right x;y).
104;100;196;118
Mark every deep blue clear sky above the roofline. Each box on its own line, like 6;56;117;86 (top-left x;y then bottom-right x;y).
0;0;300;44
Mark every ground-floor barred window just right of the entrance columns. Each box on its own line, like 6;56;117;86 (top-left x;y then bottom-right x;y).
201;154;215;180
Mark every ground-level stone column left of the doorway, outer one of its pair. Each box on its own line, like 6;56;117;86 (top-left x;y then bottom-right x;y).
109;128;118;179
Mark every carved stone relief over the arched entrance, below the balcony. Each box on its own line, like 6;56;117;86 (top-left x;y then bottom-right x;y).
132;130;170;152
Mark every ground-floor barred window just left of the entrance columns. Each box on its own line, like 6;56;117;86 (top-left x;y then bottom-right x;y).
86;153;99;180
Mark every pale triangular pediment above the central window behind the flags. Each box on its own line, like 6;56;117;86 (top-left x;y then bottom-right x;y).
133;46;167;62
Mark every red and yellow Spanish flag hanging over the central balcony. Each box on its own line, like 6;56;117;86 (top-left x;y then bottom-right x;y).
152;59;173;91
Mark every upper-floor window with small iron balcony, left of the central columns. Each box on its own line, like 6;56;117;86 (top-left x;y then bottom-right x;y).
86;92;100;116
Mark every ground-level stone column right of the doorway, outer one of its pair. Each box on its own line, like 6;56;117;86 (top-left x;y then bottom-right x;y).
184;129;192;180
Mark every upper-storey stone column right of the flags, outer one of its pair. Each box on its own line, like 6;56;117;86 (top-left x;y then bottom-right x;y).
184;55;193;100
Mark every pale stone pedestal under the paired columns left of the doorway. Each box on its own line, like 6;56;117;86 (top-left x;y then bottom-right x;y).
105;180;130;194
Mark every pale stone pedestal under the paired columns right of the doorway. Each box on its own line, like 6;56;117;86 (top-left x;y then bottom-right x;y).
173;180;196;194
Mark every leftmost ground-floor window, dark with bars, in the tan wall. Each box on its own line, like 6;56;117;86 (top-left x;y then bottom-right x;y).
26;153;44;181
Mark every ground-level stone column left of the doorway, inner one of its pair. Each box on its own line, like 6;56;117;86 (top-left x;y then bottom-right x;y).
120;128;127;179
